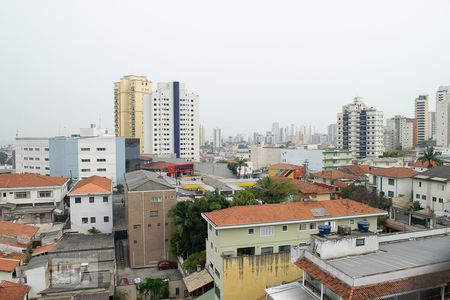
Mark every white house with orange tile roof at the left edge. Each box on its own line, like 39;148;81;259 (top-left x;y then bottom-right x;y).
0;174;69;224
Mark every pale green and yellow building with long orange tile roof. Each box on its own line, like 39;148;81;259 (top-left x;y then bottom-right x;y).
202;199;387;299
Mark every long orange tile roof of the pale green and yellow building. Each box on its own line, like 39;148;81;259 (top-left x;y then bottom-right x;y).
204;199;387;227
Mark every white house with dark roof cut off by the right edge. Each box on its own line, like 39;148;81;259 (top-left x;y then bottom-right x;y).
413;166;450;217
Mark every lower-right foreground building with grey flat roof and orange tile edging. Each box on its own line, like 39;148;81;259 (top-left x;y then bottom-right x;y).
290;228;450;300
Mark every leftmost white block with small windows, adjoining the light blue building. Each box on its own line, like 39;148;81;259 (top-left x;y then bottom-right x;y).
14;137;50;175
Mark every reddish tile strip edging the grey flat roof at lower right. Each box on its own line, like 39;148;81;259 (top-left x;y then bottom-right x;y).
295;258;450;300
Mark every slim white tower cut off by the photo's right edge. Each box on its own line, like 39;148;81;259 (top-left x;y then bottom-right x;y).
436;86;450;147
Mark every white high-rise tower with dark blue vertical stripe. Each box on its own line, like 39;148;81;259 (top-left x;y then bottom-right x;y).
144;81;200;161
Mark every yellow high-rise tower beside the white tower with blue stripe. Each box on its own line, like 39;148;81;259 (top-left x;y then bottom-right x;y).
114;75;152;153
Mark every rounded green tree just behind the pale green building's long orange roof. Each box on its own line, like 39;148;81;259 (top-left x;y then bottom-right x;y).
252;177;298;203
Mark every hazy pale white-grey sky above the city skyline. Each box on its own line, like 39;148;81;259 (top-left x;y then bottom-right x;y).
0;0;450;140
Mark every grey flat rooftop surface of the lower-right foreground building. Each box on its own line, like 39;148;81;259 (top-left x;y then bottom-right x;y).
326;235;450;278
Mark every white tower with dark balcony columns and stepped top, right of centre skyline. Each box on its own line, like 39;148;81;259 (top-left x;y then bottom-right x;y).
337;97;384;159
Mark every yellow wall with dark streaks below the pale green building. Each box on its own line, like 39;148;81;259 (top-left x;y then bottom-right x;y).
221;253;301;300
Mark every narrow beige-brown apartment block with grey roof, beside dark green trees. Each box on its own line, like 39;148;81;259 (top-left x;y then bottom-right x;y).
125;170;177;268
